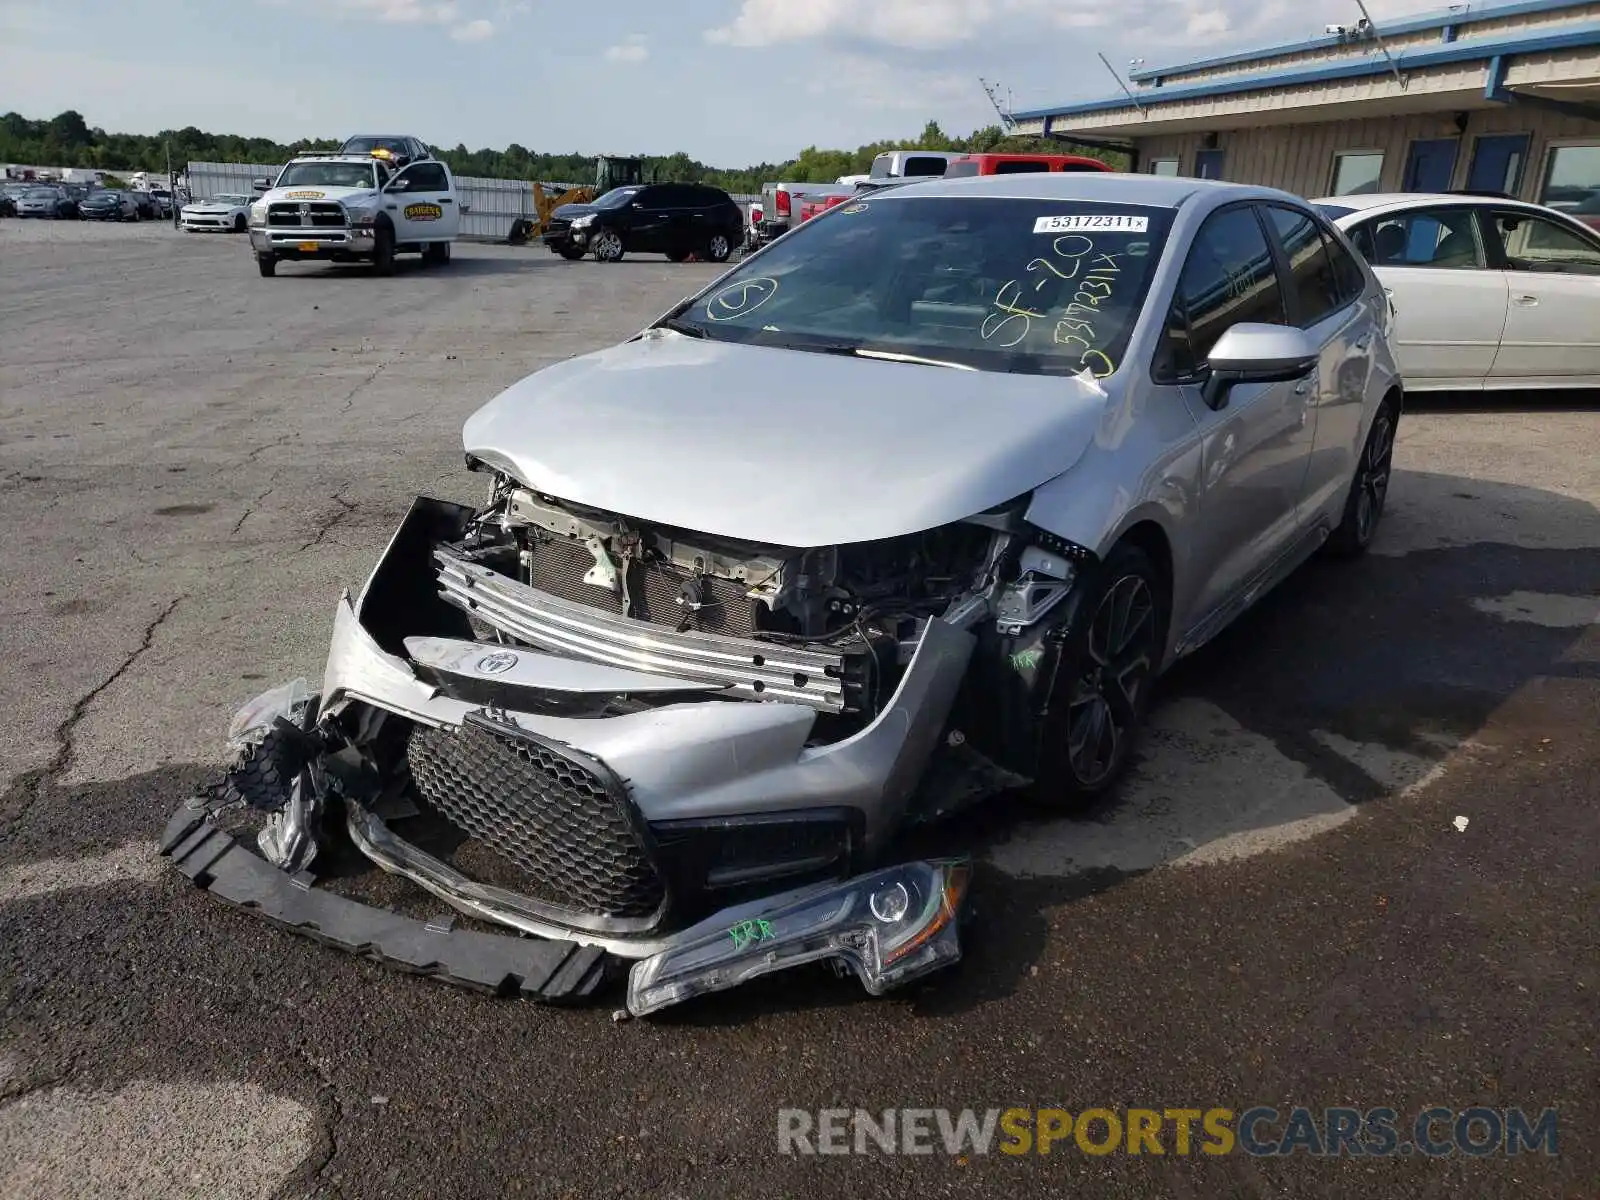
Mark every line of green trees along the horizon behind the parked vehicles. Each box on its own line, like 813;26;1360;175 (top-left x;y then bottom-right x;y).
0;110;1123;194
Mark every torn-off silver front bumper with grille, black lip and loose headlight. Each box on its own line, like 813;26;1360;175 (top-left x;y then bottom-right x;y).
163;498;974;1011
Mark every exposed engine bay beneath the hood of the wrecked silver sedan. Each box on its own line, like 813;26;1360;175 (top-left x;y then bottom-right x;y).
442;477;1003;736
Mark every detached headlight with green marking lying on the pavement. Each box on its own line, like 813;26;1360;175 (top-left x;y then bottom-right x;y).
627;859;971;1016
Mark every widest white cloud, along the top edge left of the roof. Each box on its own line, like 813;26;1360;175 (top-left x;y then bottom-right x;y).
706;0;1435;53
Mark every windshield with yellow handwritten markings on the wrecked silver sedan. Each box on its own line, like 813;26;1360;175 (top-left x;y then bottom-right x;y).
672;195;1173;378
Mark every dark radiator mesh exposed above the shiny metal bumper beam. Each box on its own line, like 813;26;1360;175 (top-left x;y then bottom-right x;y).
530;539;755;637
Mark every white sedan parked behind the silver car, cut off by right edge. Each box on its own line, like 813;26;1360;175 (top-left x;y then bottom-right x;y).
1314;195;1600;392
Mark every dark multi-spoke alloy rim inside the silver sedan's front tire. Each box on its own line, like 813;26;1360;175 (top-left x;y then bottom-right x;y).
1067;574;1157;787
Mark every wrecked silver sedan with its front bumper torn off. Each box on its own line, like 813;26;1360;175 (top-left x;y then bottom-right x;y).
166;174;1403;1013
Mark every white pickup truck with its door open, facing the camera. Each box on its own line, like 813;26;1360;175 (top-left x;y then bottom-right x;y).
250;154;461;277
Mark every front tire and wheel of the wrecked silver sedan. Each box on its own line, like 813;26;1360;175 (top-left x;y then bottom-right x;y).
1032;542;1166;808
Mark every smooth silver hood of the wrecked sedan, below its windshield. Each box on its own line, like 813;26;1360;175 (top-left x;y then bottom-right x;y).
462;333;1112;547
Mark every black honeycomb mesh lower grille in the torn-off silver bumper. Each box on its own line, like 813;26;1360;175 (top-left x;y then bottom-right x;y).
406;717;666;917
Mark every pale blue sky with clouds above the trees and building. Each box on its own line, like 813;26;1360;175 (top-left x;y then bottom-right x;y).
0;0;1438;166
